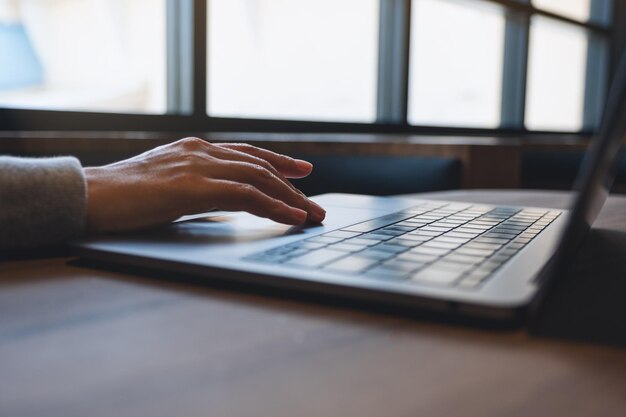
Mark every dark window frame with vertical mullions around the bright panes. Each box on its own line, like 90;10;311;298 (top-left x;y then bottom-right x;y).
0;0;626;136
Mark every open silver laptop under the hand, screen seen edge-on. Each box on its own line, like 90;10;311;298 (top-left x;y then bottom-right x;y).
73;54;626;321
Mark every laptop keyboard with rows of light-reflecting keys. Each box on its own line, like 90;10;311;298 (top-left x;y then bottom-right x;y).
244;202;560;289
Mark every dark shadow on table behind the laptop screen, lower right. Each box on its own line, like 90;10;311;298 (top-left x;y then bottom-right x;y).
530;229;626;348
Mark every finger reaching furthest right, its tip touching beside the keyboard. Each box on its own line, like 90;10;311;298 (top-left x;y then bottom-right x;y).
212;161;326;223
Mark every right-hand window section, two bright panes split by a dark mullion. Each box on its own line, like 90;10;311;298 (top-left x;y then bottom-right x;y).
408;0;611;132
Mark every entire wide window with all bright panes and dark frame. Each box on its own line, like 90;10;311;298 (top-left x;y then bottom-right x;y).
0;0;624;134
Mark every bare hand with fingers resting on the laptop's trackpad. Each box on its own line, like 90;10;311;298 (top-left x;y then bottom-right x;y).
84;138;326;233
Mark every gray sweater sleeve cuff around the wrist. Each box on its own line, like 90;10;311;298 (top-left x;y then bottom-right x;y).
0;156;87;249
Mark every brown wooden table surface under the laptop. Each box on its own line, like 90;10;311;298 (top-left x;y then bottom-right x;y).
0;192;626;417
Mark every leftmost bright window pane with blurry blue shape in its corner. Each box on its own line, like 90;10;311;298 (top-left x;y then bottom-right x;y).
0;0;165;113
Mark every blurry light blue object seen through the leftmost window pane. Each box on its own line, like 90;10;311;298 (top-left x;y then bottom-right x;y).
0;23;43;91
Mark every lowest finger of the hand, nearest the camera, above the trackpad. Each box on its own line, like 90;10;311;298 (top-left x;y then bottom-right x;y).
202;179;307;225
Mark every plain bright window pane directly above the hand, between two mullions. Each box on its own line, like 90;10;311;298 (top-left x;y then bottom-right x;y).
208;0;378;122
